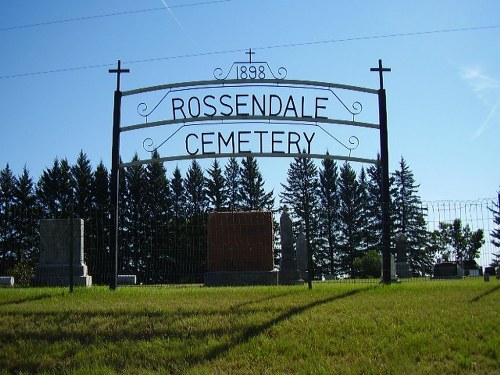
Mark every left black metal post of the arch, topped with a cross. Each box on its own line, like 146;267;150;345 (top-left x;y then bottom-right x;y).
109;60;130;290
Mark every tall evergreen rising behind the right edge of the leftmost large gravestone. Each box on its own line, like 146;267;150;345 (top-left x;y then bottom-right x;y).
71;151;94;220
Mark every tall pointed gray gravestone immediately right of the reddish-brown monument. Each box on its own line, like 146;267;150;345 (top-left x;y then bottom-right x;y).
278;207;304;285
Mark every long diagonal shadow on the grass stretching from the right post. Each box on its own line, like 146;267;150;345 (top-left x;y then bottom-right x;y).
190;286;377;367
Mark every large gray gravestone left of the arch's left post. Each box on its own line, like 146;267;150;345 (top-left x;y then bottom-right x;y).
34;219;92;286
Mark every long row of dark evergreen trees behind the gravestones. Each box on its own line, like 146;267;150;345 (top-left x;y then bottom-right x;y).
0;151;488;283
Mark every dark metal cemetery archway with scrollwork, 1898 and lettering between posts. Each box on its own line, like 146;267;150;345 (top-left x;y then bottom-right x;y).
109;55;391;290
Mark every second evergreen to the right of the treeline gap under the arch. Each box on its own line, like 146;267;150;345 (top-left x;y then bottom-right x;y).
318;154;339;275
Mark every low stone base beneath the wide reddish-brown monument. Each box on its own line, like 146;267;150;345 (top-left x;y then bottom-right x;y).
204;271;278;286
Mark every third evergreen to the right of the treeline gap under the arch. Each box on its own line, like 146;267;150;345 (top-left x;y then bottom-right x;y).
339;162;363;277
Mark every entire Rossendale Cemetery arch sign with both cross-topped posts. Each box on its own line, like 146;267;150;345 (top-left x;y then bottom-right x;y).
110;50;390;289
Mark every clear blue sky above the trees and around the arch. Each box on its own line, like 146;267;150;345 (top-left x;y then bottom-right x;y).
0;0;500;200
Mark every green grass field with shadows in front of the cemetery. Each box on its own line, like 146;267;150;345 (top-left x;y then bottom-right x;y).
0;279;500;374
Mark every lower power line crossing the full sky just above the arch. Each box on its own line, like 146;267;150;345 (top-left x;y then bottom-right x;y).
0;25;500;79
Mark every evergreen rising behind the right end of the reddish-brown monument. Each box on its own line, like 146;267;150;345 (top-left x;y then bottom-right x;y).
238;156;274;211
